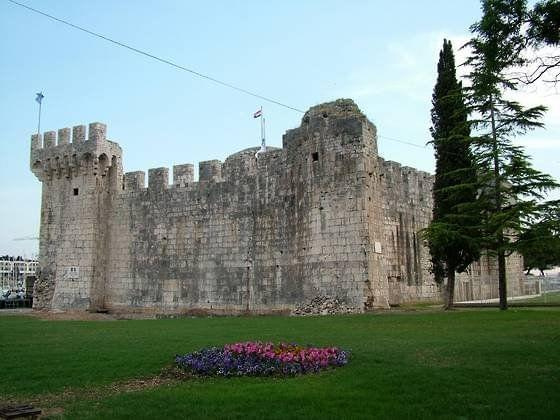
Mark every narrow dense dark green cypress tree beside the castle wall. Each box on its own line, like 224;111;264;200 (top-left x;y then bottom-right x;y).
423;39;480;309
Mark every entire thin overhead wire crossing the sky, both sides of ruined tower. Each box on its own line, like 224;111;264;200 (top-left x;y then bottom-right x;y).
8;0;426;149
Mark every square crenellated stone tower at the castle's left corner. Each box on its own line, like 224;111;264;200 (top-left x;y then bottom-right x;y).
30;123;122;310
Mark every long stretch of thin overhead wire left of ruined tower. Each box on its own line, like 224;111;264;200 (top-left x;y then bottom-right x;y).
4;0;304;114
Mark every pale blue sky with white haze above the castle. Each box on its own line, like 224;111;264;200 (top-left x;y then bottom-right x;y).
0;0;560;257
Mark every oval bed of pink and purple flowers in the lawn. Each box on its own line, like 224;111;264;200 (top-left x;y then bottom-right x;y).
175;341;348;376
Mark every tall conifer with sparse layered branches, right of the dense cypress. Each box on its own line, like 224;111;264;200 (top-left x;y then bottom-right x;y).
466;0;558;310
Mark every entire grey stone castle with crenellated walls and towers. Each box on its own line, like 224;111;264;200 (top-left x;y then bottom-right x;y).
30;100;521;314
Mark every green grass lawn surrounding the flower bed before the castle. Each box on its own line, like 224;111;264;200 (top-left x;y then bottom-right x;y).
0;309;560;419
